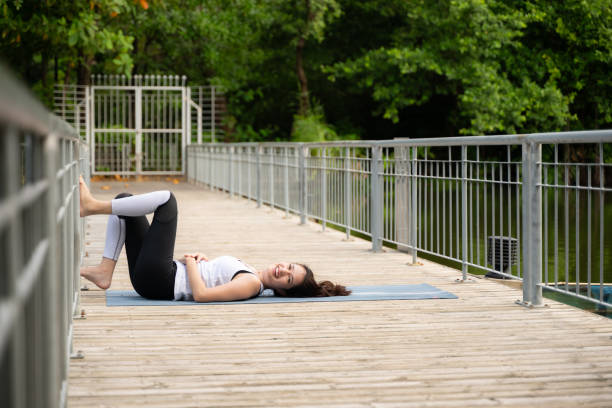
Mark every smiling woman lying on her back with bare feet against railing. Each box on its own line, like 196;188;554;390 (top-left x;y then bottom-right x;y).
80;178;350;302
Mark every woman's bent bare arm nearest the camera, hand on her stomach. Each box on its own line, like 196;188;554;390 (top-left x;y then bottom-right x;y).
186;257;261;302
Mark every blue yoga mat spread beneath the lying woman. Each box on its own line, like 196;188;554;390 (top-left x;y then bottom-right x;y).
106;283;457;306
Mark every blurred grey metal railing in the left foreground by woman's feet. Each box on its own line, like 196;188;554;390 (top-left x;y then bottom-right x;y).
0;67;89;407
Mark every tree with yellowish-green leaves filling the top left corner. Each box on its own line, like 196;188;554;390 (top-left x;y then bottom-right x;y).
0;0;141;102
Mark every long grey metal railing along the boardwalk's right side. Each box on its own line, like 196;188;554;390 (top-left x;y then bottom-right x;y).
186;130;612;307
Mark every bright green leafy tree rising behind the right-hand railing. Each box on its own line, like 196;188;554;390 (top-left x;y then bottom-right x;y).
327;0;569;134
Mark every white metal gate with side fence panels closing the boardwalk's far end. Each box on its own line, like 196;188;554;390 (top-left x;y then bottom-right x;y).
55;75;225;175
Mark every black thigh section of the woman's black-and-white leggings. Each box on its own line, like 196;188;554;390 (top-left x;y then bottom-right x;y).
115;193;178;299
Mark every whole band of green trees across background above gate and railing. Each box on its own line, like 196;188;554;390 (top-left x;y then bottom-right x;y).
0;0;612;140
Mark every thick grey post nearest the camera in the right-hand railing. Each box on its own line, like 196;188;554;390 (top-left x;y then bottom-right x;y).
521;141;542;306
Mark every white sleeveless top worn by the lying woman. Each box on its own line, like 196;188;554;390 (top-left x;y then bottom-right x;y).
174;255;264;300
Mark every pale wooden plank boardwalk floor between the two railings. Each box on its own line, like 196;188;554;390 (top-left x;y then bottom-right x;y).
68;182;612;408
